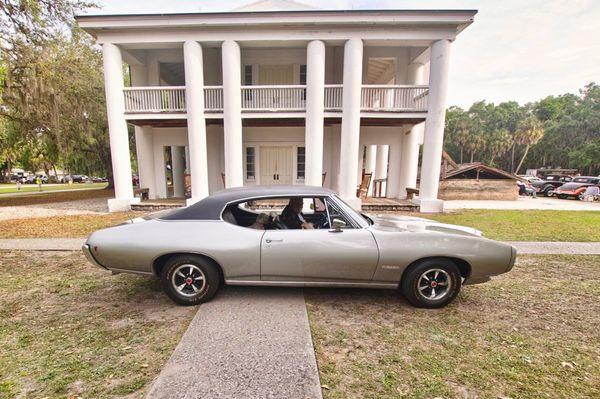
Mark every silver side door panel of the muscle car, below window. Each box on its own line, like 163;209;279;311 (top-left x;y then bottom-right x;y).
261;198;379;282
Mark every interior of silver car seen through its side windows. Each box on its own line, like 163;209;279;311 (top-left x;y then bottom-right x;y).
222;197;353;230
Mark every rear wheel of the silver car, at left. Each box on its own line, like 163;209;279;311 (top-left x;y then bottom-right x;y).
160;255;221;306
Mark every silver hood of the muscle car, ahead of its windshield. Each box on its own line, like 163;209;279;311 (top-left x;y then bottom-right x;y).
370;215;483;237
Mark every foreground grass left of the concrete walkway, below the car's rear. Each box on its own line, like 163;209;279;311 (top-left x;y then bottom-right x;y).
0;252;195;399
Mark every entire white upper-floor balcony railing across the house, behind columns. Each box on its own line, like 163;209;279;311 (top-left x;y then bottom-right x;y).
124;85;429;115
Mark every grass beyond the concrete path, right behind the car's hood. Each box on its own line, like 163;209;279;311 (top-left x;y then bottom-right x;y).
414;209;600;241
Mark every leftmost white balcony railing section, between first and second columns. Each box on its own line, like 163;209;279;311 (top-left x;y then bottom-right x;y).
123;86;185;113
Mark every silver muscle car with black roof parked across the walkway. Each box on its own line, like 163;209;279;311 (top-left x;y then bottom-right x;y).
83;186;516;308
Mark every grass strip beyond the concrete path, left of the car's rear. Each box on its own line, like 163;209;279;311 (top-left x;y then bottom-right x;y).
0;212;146;239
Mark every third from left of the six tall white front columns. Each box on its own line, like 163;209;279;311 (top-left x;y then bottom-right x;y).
222;40;244;188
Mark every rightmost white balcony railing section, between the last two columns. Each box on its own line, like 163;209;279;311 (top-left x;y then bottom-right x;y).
360;85;429;111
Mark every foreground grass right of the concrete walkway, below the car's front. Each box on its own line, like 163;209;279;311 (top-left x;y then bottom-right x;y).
305;256;600;399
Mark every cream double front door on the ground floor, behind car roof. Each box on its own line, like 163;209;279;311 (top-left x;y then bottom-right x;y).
260;146;294;185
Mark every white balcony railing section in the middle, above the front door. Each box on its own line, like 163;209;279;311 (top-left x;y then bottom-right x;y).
242;85;306;111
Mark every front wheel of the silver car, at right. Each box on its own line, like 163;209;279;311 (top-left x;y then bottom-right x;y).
401;258;462;308
